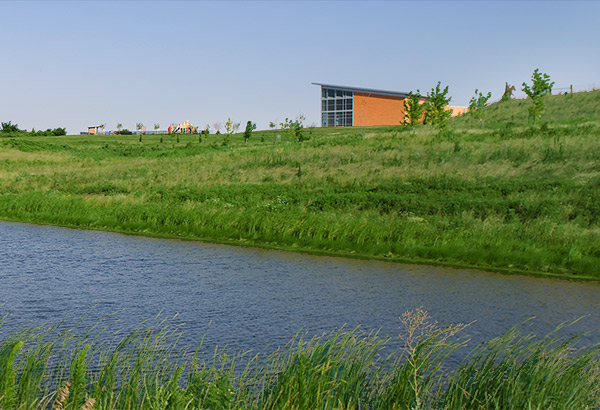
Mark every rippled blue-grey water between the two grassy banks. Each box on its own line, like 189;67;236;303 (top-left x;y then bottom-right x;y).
0;222;600;352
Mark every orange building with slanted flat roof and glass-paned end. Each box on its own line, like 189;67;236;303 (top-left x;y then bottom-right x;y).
313;83;468;127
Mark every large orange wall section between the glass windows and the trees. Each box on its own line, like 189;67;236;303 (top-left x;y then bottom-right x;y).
352;92;405;126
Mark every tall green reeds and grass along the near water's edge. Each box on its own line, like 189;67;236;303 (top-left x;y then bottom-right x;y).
0;310;600;410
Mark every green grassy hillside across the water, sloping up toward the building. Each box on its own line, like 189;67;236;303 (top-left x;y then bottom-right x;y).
0;92;600;279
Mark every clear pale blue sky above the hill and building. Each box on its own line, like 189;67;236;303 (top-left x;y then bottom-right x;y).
0;1;600;133
